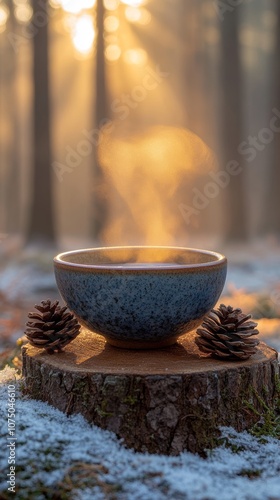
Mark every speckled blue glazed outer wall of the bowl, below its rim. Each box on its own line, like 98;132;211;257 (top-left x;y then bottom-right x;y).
55;247;227;348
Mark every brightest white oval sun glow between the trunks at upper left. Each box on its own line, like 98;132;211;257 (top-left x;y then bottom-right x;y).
72;14;95;55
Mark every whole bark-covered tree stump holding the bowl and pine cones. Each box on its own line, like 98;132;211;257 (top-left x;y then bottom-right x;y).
23;328;279;455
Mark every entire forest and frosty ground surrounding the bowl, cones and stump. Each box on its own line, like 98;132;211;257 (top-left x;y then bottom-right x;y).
0;5;280;500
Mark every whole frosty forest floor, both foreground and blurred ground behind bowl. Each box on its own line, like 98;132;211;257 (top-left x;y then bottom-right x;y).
0;240;280;500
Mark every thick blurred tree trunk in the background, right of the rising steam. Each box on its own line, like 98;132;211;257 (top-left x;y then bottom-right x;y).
220;7;248;241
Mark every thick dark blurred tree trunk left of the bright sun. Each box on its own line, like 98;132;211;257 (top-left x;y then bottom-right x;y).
26;0;55;243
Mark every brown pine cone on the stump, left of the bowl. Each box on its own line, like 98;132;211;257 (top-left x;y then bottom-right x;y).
25;300;81;354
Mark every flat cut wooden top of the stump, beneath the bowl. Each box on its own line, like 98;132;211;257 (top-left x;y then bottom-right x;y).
24;327;277;375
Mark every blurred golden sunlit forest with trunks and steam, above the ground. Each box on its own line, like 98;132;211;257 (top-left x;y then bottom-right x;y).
0;0;280;248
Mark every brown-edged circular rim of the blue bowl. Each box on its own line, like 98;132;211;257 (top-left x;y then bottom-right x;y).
53;245;227;273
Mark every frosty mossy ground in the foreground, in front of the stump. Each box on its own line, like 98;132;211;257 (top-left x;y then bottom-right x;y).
0;369;280;500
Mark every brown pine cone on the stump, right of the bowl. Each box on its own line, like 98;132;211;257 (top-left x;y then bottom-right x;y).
195;304;259;360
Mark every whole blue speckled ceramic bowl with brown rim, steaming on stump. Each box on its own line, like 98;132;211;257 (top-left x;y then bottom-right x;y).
54;247;227;349
